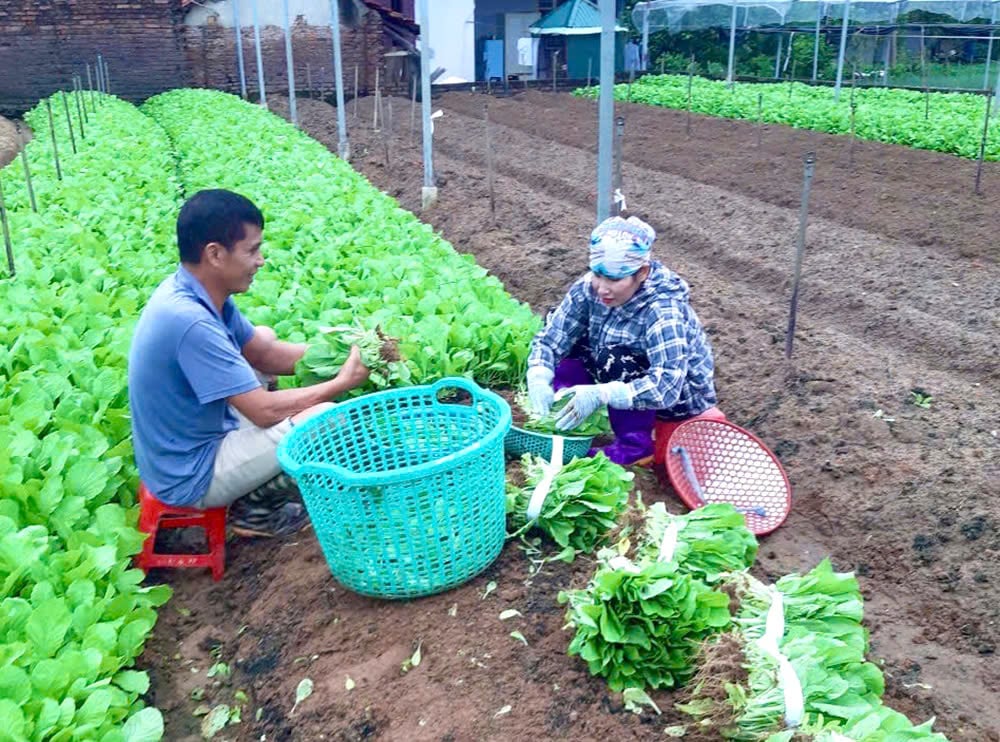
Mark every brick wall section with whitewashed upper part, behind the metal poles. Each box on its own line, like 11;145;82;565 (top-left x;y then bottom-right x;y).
184;12;385;99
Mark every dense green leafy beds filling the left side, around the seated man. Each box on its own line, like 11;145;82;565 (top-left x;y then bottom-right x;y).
0;91;538;742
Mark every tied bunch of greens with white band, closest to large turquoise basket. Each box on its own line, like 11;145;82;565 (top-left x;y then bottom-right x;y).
507;452;635;553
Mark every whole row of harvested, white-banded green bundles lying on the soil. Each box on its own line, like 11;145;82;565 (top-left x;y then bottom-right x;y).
508;454;946;742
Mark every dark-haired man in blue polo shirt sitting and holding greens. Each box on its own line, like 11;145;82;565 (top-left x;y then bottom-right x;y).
128;190;368;536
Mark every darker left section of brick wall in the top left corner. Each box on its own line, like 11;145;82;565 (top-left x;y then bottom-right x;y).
0;0;191;113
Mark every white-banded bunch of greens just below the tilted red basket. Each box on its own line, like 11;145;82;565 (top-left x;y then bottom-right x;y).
634;502;757;584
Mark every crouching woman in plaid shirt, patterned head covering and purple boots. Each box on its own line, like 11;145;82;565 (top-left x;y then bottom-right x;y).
527;217;716;464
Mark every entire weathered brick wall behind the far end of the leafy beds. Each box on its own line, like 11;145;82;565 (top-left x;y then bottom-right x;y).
0;0;398;116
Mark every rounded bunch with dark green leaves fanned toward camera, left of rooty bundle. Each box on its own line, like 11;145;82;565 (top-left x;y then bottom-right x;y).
559;557;732;691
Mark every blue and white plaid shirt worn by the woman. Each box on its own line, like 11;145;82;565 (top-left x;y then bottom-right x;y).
528;261;716;417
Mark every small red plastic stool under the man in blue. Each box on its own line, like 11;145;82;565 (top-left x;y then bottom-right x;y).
135;484;226;582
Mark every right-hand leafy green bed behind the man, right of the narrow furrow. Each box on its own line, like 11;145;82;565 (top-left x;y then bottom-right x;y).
143;90;540;385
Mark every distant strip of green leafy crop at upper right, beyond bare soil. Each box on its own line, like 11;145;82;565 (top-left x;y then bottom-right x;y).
576;75;1000;160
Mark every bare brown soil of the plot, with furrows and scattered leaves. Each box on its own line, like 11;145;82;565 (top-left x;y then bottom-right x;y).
144;93;1000;741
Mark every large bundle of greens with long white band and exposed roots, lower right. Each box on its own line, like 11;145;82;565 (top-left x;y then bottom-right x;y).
678;560;884;742
